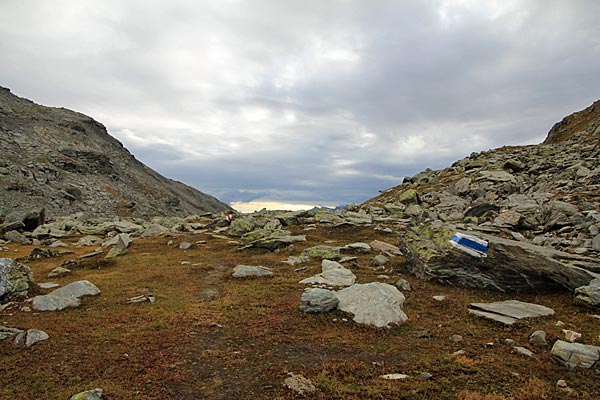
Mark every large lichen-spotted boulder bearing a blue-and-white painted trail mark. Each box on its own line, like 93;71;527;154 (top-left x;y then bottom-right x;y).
399;225;597;292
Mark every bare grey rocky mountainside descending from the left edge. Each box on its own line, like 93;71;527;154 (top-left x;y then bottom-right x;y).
0;87;231;217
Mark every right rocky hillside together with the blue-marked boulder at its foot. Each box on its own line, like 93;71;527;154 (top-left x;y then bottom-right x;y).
361;102;600;290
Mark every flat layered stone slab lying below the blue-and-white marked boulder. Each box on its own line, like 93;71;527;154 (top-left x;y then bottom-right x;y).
469;300;554;325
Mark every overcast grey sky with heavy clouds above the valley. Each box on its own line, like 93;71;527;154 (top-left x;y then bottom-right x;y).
0;0;600;211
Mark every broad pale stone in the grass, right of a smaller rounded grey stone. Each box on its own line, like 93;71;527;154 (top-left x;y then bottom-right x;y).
337;282;408;328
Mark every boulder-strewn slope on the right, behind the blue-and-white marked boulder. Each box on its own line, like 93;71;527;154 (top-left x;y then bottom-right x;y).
360;102;600;272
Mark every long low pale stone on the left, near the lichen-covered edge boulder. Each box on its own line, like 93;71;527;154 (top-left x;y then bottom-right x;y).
32;280;100;311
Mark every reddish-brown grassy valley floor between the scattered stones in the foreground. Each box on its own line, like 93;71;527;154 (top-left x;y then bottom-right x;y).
0;226;600;400
